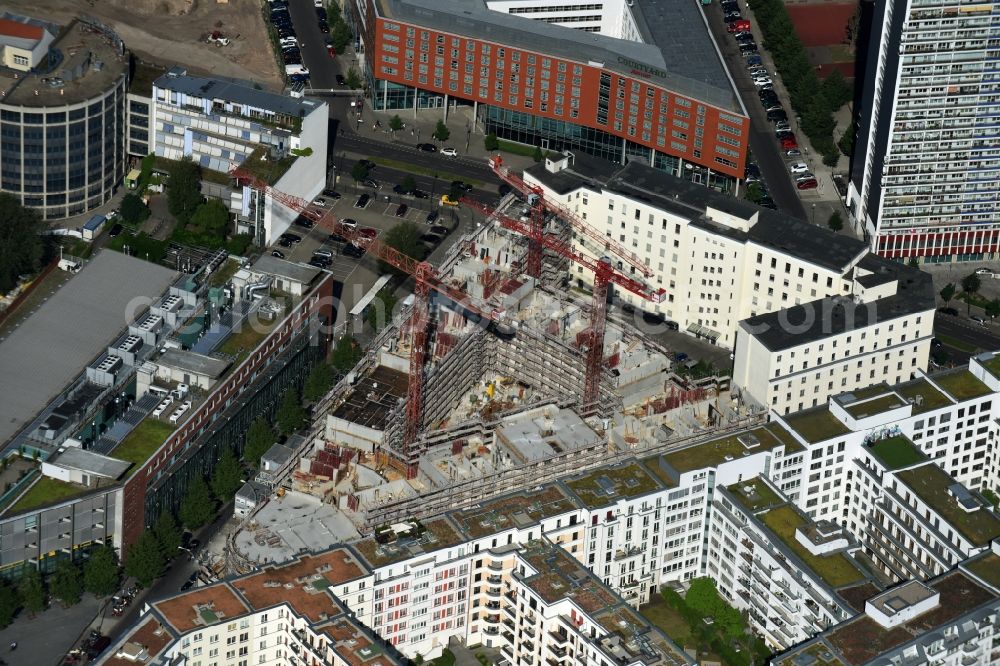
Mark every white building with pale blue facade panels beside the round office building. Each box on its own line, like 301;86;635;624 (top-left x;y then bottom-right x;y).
149;67;329;246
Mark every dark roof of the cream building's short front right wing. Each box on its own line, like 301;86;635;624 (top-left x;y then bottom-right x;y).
741;254;934;351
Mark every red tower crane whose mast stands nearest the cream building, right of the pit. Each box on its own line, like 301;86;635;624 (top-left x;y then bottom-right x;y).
462;197;666;411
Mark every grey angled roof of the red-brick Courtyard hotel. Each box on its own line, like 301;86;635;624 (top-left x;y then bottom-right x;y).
375;0;746;115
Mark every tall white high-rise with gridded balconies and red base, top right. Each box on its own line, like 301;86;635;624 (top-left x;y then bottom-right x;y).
847;0;1000;262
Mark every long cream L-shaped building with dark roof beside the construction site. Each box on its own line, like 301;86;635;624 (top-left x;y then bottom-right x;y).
525;154;934;413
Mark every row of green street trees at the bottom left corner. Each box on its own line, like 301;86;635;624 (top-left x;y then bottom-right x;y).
0;546;121;629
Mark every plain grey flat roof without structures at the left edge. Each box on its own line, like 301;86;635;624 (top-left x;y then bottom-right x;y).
0;250;176;442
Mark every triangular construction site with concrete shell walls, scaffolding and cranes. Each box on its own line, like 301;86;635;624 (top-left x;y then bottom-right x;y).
223;158;763;565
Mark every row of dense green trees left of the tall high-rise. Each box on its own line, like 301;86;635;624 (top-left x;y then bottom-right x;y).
753;0;853;166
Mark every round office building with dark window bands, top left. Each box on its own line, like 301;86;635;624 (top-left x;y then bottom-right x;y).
0;17;129;220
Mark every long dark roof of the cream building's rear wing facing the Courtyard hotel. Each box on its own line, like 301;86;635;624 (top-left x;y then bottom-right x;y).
527;153;867;272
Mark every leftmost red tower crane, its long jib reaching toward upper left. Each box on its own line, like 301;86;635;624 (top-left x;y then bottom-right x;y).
229;166;505;456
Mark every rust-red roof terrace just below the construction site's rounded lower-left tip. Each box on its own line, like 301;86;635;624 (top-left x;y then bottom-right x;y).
232;548;365;622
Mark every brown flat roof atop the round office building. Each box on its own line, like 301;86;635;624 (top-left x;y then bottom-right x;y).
0;19;129;105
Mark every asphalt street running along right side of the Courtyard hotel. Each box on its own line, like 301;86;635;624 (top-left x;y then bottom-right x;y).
703;3;806;220
